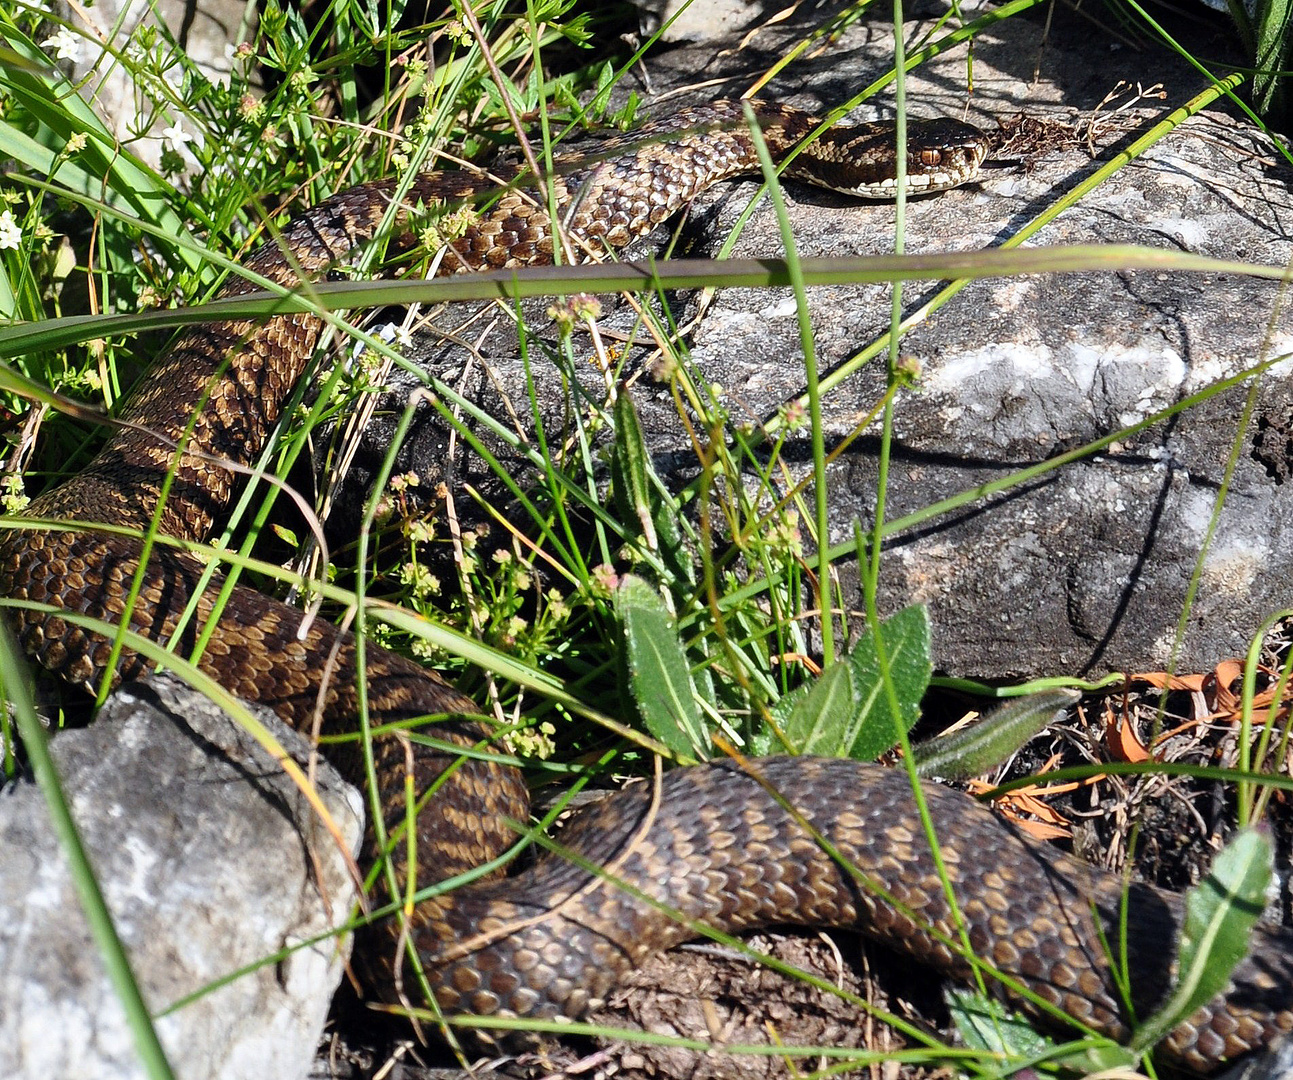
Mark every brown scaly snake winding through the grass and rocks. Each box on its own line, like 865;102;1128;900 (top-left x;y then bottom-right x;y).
0;102;1293;1072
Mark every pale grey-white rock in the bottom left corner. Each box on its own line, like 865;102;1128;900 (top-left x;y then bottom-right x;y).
0;676;363;1080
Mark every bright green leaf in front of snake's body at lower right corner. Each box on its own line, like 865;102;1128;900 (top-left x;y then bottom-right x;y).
1135;829;1272;1050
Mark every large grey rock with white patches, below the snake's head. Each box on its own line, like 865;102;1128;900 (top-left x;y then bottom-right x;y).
692;90;1293;676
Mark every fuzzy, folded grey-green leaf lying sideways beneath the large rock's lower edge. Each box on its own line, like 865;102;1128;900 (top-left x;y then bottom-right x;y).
912;688;1081;780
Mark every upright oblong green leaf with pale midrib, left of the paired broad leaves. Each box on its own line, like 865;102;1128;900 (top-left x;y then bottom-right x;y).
615;574;710;757
